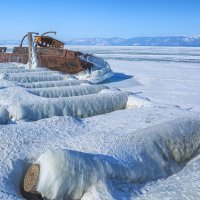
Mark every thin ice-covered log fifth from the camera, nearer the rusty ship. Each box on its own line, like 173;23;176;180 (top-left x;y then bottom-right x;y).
4;74;64;83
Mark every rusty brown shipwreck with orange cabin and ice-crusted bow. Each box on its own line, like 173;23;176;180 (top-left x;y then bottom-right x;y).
0;31;112;82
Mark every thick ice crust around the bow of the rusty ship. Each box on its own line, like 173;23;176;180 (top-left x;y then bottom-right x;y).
76;55;113;83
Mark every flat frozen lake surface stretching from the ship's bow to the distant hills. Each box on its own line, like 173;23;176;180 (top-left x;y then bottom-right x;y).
67;46;200;110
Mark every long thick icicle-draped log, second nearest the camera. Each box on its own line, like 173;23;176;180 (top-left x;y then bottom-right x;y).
9;92;128;120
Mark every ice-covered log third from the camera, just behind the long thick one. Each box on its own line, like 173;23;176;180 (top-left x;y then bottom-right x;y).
29;84;107;98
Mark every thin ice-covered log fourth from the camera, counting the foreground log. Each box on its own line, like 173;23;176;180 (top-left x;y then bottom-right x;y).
19;80;88;88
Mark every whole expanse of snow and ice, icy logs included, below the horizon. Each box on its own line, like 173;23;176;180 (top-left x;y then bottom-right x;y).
0;46;200;200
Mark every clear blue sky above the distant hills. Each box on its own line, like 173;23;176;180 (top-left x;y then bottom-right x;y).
0;0;200;40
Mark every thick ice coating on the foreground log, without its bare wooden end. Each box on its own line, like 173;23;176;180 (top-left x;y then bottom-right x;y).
29;119;200;199
